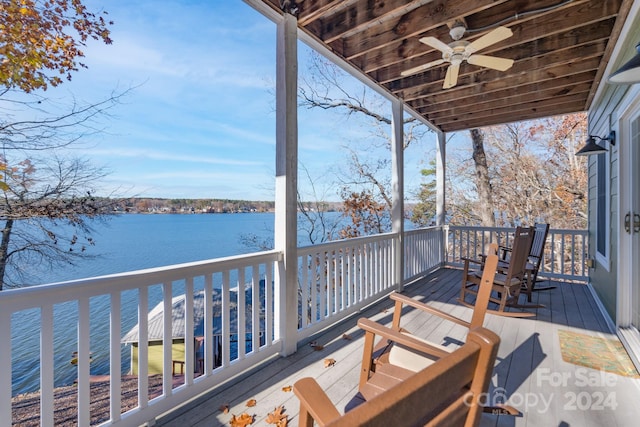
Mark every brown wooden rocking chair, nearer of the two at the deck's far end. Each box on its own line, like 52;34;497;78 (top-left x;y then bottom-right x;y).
458;227;542;317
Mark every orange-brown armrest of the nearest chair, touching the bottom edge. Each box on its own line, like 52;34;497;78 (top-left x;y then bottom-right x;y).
293;377;340;426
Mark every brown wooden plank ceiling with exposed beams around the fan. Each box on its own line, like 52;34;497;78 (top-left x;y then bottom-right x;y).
263;0;633;132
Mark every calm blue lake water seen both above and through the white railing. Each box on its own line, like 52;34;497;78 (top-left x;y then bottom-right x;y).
12;213;338;395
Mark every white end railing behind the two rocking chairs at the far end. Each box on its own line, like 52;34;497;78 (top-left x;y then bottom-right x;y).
446;226;589;282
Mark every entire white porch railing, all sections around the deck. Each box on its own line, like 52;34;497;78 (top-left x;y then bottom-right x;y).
0;227;587;427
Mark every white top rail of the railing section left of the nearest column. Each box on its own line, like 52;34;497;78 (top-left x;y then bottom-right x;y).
0;250;282;311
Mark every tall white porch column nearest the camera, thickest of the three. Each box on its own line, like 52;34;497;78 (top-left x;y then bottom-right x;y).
274;13;298;356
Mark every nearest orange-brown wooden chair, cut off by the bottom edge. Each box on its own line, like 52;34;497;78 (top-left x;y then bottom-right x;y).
293;330;500;427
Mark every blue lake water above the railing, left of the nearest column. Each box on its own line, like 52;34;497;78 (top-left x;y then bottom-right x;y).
25;213;274;284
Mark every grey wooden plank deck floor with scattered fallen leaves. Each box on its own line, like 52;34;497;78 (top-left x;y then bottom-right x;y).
156;269;640;427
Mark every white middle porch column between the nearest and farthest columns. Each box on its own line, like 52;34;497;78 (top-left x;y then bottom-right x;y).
391;99;404;291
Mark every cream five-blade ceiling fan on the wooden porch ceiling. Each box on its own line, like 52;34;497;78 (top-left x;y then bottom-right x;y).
400;22;513;89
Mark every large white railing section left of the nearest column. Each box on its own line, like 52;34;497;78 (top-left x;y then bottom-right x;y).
0;251;281;427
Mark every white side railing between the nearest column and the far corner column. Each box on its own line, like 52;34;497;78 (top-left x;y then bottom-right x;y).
298;227;444;340
